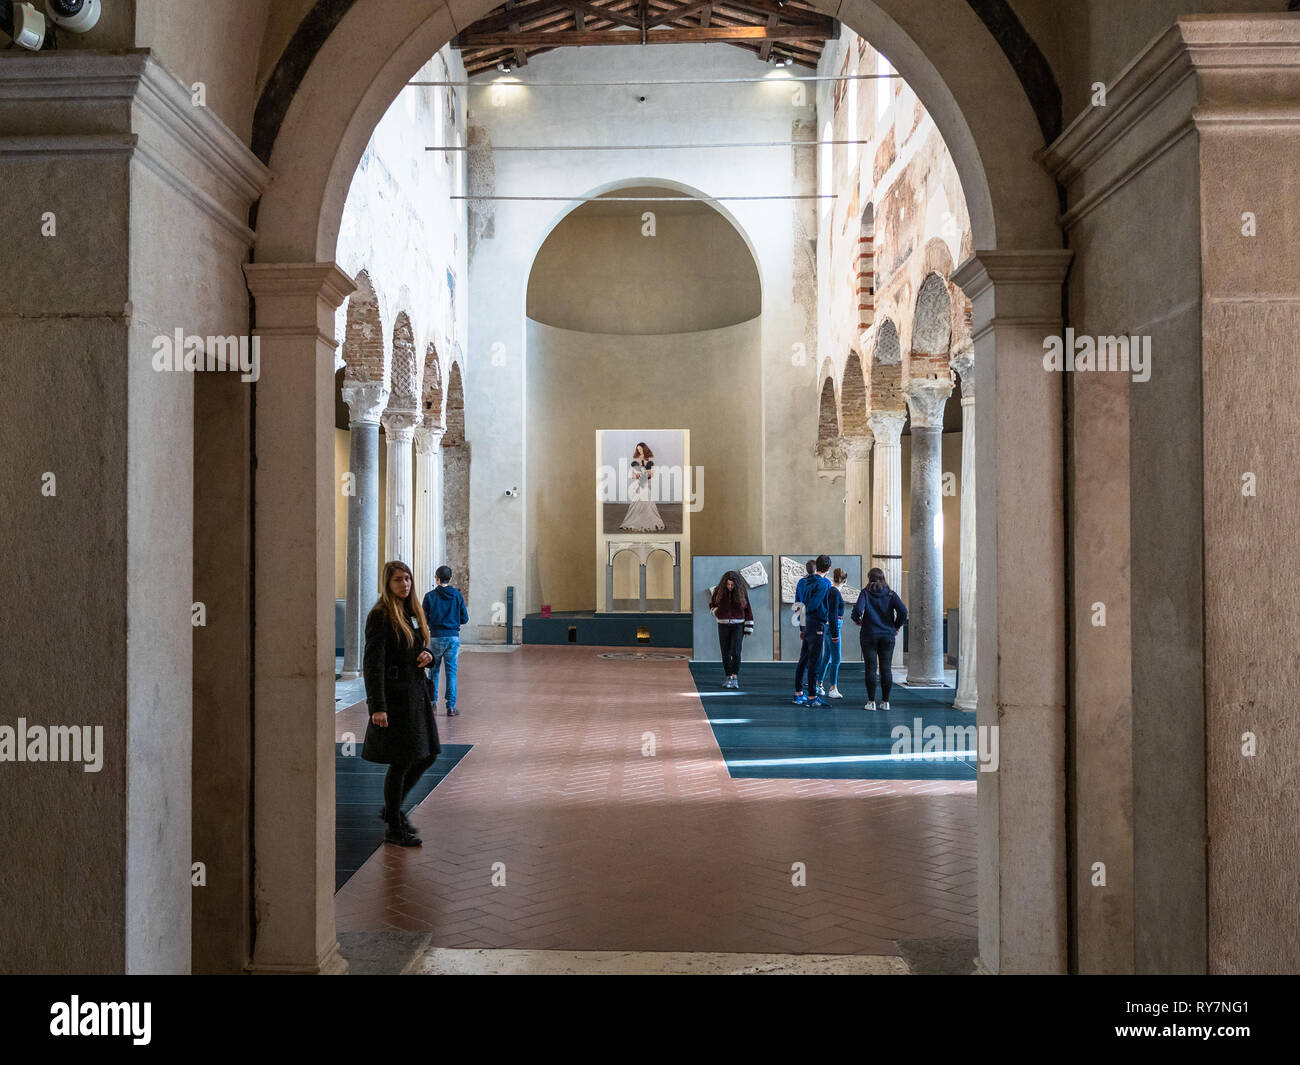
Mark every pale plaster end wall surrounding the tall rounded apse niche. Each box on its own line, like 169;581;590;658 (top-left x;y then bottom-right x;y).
465;44;844;623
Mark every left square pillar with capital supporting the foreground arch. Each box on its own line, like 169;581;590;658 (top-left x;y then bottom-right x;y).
244;263;355;973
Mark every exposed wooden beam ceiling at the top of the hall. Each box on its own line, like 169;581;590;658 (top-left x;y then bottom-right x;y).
452;0;840;77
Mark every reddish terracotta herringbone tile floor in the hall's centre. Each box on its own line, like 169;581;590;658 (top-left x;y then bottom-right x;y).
335;645;976;954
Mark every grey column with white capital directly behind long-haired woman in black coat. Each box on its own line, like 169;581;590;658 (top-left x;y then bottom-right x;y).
342;380;389;680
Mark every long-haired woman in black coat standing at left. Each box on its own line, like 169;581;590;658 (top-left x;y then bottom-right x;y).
361;562;442;847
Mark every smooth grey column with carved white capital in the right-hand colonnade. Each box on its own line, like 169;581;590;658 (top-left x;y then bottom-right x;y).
904;378;953;688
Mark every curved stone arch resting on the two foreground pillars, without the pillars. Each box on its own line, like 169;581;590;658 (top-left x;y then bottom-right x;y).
255;0;1062;263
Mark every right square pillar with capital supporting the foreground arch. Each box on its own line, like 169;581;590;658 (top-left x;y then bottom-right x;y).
950;248;1071;973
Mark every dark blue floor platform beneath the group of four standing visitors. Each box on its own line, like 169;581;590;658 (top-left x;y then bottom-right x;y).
690;662;978;780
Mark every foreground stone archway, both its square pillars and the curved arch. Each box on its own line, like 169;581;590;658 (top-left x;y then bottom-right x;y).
246;0;1070;971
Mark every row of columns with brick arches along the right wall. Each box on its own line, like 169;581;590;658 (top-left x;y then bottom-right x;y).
835;273;978;710
